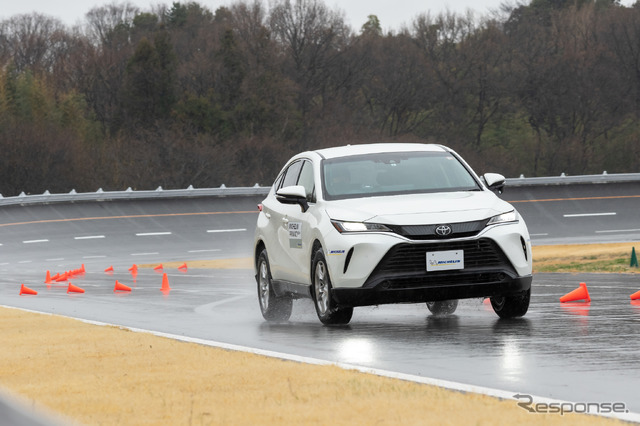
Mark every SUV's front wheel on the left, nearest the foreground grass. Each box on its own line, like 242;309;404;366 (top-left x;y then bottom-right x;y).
311;248;353;325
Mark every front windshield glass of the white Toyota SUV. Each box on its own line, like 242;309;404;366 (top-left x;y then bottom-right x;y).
322;152;480;200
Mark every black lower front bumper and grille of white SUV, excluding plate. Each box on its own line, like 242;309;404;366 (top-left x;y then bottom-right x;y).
333;236;532;306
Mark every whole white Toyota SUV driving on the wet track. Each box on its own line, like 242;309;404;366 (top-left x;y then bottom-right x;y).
254;143;532;324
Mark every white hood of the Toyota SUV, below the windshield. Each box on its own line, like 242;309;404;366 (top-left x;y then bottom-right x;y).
326;191;513;225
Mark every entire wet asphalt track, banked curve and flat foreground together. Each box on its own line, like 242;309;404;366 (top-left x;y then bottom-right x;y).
0;185;640;420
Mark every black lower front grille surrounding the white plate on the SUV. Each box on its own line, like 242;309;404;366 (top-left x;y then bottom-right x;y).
366;238;517;288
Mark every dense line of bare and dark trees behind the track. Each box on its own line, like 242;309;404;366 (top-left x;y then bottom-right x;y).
0;0;640;196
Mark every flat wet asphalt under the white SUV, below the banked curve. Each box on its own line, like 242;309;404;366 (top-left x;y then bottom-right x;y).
0;269;640;412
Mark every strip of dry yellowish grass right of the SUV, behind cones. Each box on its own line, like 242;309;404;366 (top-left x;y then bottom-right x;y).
533;243;640;273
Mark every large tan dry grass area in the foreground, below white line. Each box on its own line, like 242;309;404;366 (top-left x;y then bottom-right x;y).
0;308;624;425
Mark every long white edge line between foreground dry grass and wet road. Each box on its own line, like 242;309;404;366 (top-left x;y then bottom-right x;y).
0;305;640;422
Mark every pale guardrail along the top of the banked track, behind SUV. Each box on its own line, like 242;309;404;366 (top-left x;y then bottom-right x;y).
0;172;640;206
